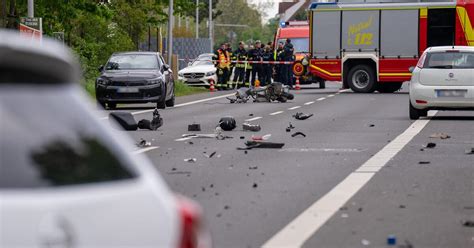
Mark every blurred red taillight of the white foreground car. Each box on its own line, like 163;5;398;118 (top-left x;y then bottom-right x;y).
177;196;212;248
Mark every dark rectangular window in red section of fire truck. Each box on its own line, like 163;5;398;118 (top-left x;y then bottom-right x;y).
428;9;456;47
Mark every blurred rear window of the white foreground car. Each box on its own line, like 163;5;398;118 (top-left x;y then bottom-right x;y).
0;86;135;188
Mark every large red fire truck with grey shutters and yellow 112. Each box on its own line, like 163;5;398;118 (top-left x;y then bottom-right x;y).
309;0;474;93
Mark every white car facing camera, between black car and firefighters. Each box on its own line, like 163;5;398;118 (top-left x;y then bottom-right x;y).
178;53;217;86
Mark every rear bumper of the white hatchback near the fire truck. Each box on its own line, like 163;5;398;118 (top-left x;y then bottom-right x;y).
410;82;474;110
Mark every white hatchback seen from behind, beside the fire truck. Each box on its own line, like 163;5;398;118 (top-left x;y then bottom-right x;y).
409;46;474;120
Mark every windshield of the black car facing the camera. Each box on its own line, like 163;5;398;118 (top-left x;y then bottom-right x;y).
105;54;158;70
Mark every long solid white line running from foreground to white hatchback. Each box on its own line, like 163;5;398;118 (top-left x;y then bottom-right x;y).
262;111;436;248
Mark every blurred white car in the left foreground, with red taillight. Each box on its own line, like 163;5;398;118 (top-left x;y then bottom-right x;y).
0;30;209;248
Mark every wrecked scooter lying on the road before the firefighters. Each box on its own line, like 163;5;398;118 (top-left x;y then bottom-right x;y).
227;82;295;103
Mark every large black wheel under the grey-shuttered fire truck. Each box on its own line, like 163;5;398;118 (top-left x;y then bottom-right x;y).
347;65;376;93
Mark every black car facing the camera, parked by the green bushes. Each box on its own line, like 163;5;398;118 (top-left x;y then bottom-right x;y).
95;52;175;109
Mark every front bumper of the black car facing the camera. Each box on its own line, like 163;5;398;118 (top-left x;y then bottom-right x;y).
96;84;166;103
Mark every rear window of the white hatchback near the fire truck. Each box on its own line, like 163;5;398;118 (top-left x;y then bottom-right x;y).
426;51;474;69
